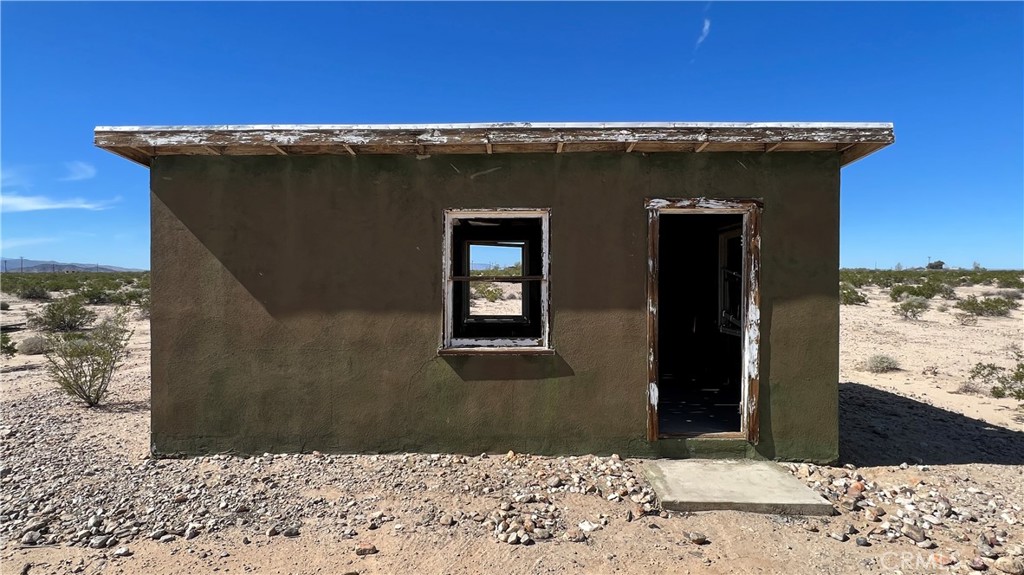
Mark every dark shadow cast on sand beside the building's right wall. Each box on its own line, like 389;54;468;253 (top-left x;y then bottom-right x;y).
839;383;1024;467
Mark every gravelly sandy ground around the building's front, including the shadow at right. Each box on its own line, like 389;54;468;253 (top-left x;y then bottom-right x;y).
0;292;1024;574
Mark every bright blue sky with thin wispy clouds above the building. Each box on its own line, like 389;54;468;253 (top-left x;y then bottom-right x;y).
0;2;1024;268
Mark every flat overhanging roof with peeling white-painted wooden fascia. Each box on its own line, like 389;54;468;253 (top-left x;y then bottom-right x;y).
95;122;895;166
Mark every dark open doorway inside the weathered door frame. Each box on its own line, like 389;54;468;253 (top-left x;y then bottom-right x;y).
657;213;745;437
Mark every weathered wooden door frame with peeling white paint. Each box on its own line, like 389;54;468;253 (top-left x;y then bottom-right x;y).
645;197;763;444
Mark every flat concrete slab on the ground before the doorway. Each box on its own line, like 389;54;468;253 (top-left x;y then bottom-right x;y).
644;459;835;516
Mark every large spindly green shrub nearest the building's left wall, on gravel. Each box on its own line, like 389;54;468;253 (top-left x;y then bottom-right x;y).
46;307;131;407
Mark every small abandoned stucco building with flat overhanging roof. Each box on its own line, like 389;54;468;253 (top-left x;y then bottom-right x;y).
95;123;893;461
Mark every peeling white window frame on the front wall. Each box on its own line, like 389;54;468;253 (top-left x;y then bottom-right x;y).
438;208;553;354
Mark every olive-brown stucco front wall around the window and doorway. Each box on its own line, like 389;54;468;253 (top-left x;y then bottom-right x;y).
152;152;840;460
